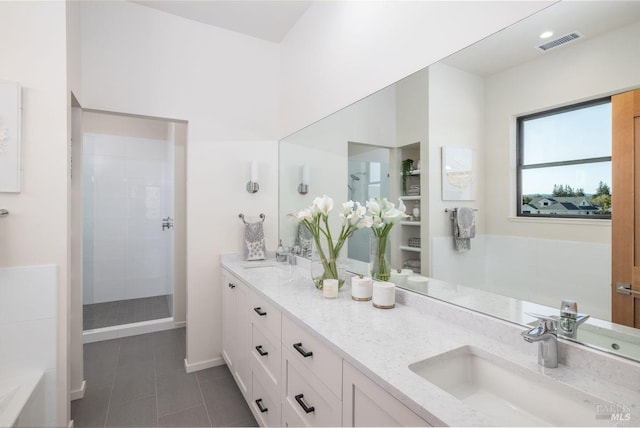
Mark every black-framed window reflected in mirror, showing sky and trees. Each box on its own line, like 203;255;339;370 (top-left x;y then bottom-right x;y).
517;98;611;218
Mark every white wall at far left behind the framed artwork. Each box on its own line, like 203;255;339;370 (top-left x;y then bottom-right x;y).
0;1;70;426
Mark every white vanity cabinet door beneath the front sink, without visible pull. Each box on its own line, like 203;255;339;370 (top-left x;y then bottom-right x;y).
342;361;431;427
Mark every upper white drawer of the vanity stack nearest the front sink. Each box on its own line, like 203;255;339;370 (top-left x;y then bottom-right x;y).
282;317;342;399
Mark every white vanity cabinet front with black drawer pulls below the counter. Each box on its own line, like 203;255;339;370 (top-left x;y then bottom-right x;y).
222;271;428;427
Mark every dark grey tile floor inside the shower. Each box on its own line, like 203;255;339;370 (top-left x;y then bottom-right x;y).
82;295;171;330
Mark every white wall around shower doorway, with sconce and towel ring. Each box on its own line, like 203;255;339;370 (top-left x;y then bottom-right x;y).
82;2;280;369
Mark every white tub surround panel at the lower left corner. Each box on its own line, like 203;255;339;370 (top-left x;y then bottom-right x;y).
0;265;57;427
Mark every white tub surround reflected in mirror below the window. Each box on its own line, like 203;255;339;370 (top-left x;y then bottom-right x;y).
431;235;611;320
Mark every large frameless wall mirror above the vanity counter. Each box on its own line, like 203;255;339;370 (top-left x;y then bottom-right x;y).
279;1;640;360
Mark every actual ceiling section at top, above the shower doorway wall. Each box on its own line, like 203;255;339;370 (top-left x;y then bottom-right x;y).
132;0;312;43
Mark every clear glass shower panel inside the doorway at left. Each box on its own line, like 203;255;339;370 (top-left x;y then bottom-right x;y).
83;132;174;330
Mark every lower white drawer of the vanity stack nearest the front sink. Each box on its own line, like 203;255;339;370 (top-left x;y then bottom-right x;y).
282;350;342;427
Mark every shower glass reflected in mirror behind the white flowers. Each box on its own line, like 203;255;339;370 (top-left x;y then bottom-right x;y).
347;142;390;262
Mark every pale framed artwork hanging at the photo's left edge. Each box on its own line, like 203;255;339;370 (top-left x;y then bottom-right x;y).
0;82;21;192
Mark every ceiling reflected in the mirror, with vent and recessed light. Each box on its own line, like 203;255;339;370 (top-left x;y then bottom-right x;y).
442;1;640;76
